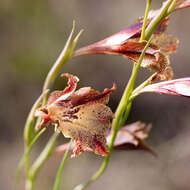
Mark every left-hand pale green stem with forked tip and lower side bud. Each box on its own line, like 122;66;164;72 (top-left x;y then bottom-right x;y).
19;22;82;190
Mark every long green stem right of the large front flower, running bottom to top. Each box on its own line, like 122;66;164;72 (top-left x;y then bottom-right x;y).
75;0;175;190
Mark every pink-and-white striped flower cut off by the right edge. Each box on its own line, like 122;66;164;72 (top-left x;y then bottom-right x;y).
137;77;190;97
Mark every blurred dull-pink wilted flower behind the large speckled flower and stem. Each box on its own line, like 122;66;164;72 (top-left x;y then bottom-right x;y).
56;121;155;155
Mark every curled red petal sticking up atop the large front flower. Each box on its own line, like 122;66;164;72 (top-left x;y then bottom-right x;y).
47;73;79;105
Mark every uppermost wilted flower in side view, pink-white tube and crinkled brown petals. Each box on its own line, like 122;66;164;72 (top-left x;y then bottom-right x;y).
74;0;190;80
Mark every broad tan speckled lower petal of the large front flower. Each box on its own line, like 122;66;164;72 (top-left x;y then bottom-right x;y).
60;103;113;156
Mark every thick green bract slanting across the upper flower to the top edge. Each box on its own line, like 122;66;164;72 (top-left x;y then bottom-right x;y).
145;0;175;40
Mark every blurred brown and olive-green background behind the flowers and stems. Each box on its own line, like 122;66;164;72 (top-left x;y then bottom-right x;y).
0;0;190;190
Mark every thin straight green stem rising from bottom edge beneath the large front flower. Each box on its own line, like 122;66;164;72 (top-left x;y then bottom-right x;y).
53;140;72;190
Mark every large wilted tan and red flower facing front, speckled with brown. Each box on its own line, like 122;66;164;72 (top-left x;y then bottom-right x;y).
36;73;116;156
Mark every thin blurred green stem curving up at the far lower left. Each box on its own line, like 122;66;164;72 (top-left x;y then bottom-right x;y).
15;128;46;190
